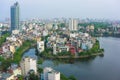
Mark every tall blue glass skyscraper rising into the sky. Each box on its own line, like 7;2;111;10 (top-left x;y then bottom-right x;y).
10;2;19;32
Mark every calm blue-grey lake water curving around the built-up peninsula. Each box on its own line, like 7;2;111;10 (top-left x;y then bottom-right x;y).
25;37;120;80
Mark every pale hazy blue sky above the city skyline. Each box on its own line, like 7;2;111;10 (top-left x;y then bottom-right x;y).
0;0;120;20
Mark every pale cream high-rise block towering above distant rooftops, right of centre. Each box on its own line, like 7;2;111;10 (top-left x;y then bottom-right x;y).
69;19;78;31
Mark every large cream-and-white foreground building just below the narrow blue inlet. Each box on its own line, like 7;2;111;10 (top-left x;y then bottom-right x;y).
20;57;37;76
